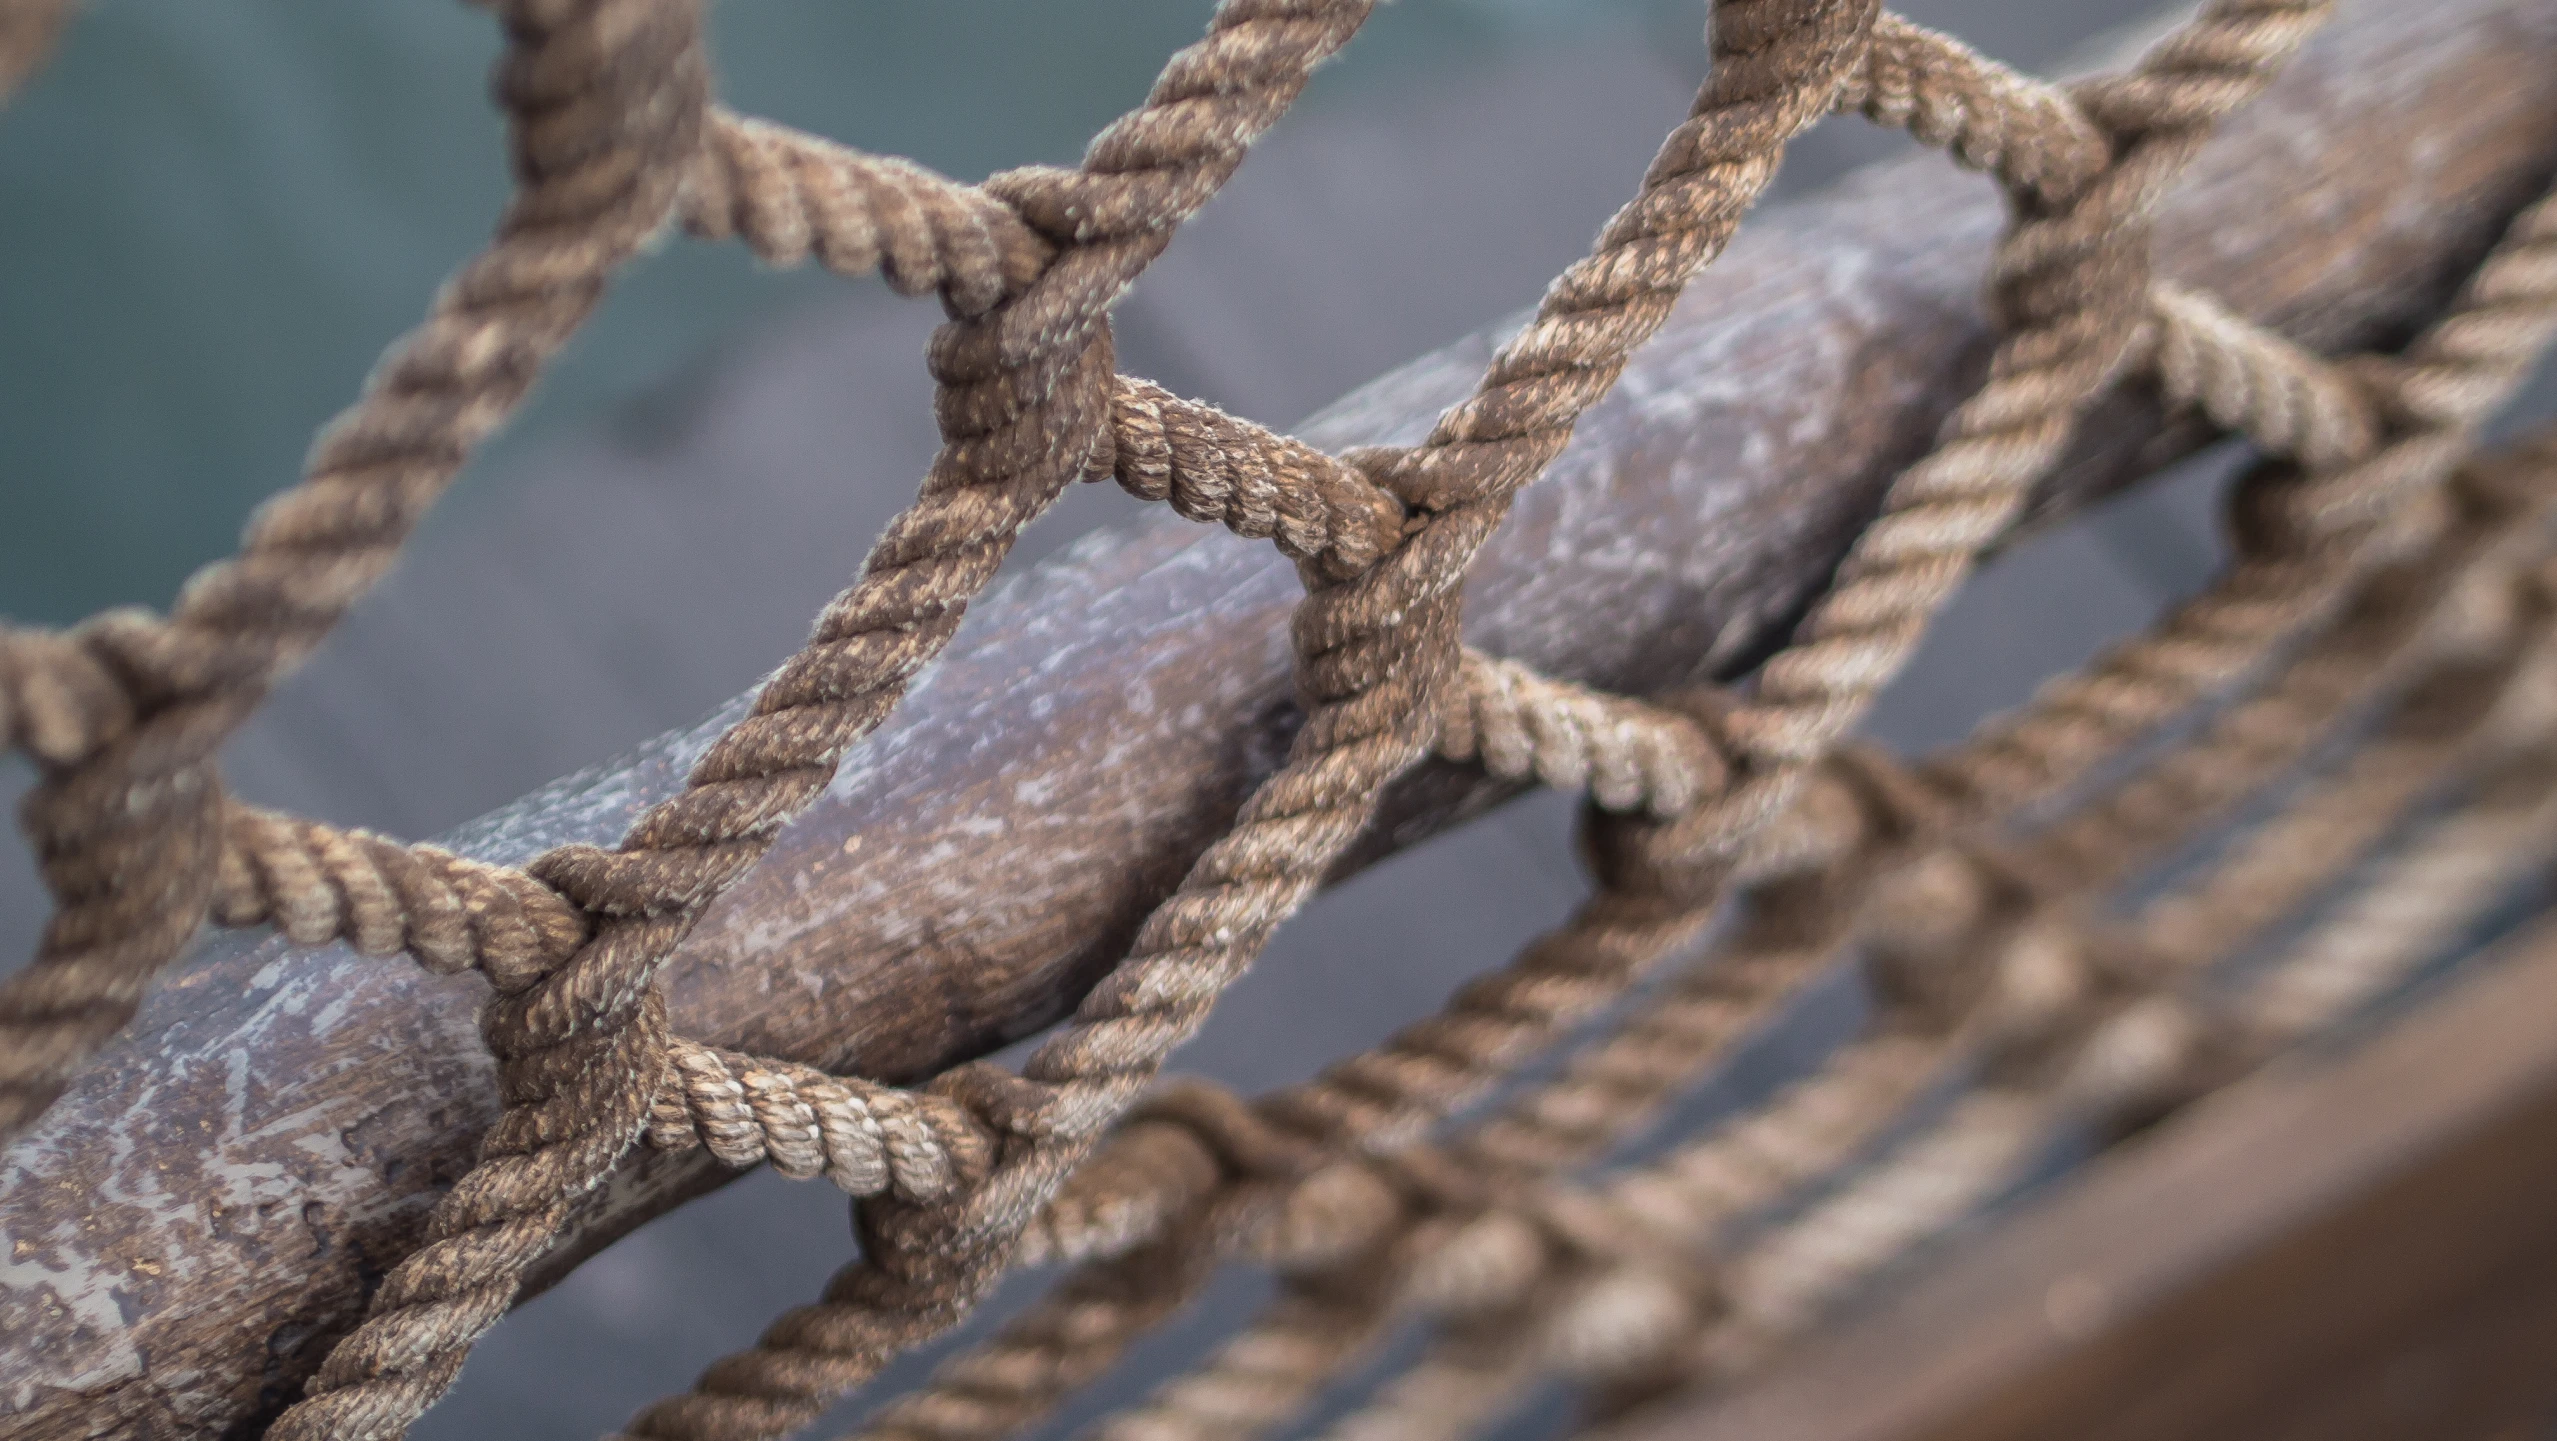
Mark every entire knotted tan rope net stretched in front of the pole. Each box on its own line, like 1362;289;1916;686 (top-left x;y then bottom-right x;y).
0;0;2557;1441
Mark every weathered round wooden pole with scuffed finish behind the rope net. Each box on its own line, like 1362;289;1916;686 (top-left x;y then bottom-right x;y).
0;0;2557;1436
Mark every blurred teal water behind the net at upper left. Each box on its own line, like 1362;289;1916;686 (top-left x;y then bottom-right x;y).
0;0;1703;623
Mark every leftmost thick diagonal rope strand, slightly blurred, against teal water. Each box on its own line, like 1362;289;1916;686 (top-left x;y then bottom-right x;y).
0;0;708;1154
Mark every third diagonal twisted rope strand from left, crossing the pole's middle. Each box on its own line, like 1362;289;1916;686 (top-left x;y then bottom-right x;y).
634;0;1874;1441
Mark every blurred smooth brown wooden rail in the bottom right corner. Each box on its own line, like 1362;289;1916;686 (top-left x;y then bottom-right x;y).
1611;927;2557;1441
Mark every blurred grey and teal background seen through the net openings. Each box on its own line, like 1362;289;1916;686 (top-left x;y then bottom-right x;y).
0;0;2526;1441
